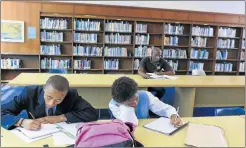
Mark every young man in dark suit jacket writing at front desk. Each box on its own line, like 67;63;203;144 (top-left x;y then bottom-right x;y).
1;75;98;130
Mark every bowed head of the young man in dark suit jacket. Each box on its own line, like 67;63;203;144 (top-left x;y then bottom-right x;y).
44;75;69;108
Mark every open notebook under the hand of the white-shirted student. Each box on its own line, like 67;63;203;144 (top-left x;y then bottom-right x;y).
144;117;188;135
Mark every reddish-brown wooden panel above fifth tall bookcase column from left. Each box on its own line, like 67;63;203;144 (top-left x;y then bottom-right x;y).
162;10;189;20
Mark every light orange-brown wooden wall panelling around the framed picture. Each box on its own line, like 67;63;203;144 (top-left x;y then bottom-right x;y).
1;1;41;53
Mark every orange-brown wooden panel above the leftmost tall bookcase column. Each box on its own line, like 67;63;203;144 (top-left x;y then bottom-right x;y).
41;4;73;14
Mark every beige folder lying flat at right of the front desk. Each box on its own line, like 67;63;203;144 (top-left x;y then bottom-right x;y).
184;123;228;147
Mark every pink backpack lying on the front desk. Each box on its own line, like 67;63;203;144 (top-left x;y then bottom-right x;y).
74;119;143;147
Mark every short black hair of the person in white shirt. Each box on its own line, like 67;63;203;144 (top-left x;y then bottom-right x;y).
111;76;138;103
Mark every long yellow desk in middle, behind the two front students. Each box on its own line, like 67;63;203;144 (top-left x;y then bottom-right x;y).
9;73;245;117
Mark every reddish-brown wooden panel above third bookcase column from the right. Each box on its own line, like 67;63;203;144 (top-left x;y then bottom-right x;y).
189;12;214;23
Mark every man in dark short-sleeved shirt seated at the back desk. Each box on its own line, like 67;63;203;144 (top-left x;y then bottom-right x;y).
138;47;175;99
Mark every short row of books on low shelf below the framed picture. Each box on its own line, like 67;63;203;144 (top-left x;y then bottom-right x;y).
1;58;21;69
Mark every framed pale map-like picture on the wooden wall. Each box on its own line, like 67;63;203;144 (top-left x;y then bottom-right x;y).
1;20;25;42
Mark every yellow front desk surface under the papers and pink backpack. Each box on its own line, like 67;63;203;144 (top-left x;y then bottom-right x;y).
1;116;245;147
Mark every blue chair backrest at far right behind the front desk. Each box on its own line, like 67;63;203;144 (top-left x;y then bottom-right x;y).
215;107;245;116
